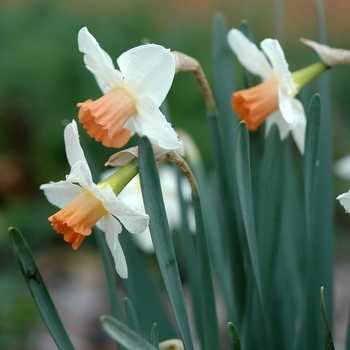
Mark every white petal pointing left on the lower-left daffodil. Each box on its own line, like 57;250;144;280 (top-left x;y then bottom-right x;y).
40;181;84;208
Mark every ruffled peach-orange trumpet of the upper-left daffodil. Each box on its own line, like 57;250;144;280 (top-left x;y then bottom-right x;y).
77;86;136;148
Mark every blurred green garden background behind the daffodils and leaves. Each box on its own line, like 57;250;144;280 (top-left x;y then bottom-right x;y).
0;0;350;349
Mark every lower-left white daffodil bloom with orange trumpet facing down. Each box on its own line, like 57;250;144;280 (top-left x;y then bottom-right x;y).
40;121;149;278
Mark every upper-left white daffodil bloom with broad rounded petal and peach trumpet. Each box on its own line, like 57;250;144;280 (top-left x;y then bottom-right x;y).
78;27;183;153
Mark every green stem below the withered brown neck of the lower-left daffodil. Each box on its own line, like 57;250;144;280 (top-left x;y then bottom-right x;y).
192;192;220;350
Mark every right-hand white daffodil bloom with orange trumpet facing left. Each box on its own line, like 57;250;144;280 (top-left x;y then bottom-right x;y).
228;29;306;154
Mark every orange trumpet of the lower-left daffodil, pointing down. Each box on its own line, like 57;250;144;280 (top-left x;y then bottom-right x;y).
49;191;107;249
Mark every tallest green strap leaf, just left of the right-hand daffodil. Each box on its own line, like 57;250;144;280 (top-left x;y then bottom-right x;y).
211;13;245;329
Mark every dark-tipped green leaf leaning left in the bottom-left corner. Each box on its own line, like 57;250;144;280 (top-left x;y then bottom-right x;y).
8;227;74;350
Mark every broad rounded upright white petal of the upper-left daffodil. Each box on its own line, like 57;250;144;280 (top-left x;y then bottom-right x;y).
117;44;175;107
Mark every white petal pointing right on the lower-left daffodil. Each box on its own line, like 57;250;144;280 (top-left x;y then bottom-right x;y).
103;190;149;233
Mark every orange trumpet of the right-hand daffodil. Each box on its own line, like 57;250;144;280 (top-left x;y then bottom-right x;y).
231;79;278;131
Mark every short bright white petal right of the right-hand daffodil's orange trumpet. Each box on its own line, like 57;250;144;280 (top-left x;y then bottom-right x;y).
278;85;306;125
